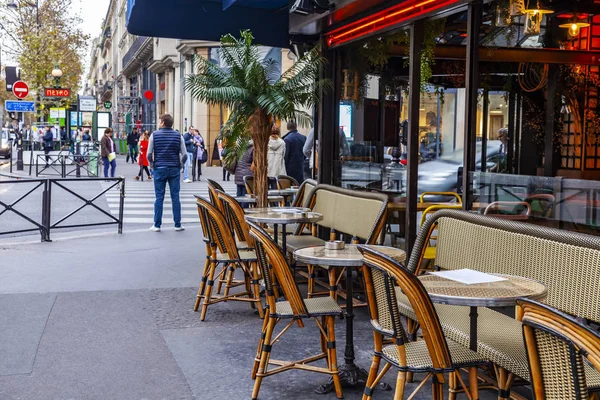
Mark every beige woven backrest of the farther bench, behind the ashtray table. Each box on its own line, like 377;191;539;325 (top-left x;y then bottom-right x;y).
305;185;388;244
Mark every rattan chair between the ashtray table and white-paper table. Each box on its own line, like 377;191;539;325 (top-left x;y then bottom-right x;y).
359;245;486;400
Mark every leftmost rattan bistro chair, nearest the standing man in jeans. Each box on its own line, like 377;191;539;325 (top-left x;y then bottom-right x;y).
196;196;263;321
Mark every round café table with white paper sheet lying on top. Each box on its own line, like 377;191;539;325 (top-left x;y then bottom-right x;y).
419;274;548;351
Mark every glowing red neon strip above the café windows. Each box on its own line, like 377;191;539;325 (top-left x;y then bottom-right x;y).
327;0;459;47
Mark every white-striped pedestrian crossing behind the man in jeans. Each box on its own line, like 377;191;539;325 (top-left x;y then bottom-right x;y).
103;180;236;226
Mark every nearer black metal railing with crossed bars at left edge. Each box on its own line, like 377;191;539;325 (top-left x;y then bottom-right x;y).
0;177;125;242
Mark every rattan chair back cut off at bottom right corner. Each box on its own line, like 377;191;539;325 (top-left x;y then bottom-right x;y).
517;299;600;400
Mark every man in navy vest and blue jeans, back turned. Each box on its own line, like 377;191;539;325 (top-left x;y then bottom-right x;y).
148;114;187;232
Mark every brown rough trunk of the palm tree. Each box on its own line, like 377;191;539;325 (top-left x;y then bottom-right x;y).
252;108;271;207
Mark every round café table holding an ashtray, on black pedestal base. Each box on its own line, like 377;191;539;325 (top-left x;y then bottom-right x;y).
294;244;406;394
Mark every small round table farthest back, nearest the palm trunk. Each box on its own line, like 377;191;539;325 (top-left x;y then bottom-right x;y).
244;207;323;252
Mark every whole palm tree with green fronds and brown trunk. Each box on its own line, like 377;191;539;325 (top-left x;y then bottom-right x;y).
185;31;331;207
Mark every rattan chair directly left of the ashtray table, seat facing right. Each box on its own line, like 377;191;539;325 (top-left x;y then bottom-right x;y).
249;223;343;399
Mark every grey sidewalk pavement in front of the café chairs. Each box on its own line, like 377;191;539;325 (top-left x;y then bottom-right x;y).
0;159;496;400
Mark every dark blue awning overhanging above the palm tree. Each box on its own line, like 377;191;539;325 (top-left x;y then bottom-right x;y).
127;0;290;47
